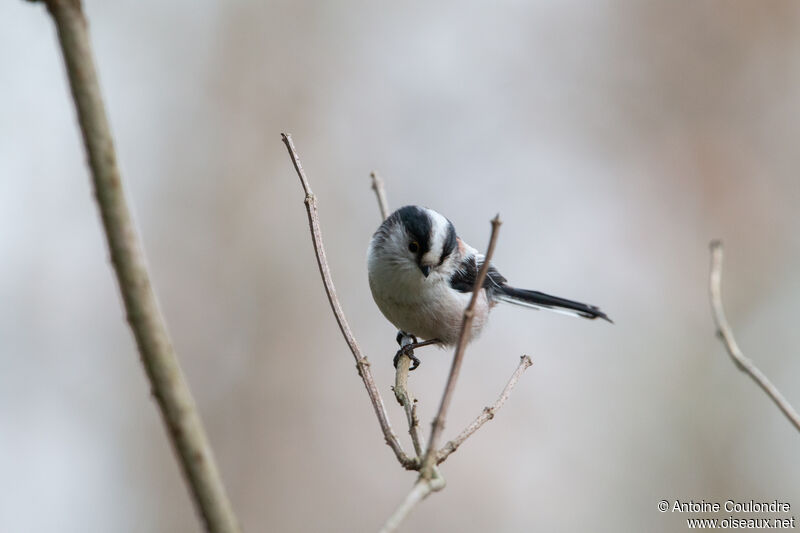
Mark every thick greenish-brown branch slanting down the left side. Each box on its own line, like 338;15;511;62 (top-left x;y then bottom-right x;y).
32;0;239;533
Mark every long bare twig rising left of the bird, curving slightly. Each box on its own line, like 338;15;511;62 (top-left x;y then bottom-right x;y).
281;133;419;470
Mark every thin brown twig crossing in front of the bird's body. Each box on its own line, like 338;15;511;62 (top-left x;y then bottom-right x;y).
421;215;501;480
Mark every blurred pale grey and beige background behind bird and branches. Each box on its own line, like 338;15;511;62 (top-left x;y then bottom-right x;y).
0;0;800;532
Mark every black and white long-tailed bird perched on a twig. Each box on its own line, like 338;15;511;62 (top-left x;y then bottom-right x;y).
367;205;613;370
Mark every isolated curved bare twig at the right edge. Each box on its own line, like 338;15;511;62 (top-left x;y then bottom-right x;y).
709;240;800;431
